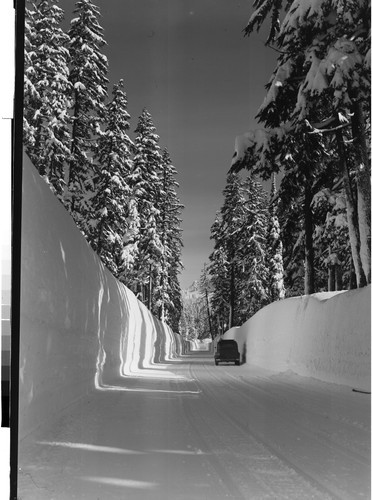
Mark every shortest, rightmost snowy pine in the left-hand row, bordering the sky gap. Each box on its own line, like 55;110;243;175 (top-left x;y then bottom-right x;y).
154;149;184;321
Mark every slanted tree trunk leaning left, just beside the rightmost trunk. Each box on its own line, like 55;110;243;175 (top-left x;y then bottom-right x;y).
336;130;366;288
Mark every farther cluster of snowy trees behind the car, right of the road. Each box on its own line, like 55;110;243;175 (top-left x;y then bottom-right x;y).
180;172;287;338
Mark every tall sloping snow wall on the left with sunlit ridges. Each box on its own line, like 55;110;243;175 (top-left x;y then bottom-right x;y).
19;155;182;439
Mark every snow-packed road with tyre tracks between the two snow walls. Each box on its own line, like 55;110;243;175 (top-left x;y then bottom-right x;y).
19;353;370;500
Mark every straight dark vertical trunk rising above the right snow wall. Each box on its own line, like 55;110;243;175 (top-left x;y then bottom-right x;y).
304;178;315;295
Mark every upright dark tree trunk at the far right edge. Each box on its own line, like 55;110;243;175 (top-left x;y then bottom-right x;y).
351;102;371;283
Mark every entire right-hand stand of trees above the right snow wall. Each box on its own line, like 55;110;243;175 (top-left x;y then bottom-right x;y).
186;0;371;335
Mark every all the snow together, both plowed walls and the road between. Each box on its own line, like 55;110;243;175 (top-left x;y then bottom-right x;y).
19;154;370;500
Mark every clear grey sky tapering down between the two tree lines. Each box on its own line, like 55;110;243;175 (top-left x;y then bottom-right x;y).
59;0;276;288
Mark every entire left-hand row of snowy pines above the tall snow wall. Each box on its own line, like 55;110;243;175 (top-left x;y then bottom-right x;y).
23;0;183;331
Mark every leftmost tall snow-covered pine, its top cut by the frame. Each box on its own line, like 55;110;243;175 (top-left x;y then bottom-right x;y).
23;0;71;198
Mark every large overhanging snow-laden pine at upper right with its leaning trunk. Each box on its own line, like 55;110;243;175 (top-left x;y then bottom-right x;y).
246;0;371;286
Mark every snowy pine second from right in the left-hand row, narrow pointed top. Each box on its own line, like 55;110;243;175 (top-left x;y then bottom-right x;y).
130;109;164;312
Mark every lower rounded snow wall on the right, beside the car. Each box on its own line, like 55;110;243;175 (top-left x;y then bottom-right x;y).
223;286;371;390
